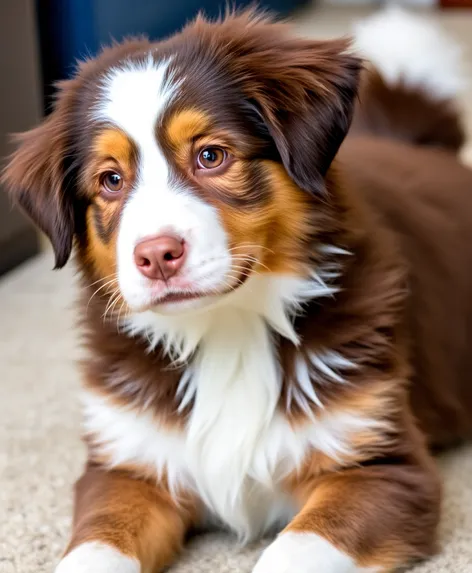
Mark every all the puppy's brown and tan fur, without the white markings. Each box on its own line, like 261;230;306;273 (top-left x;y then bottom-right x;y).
5;7;472;571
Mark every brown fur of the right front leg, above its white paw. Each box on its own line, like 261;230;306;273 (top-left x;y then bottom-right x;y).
285;464;439;571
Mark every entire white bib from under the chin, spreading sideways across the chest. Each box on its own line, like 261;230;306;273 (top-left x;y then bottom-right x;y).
84;278;369;539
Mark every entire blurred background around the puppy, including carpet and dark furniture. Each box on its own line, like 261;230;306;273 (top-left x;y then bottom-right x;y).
0;0;472;573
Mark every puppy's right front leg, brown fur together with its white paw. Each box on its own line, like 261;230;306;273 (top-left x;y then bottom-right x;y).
253;463;440;573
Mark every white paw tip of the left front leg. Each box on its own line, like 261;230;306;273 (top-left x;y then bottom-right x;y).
55;541;141;573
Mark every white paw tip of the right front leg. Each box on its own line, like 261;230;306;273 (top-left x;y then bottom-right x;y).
253;532;375;573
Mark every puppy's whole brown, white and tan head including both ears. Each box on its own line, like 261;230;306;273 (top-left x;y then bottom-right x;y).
4;12;360;318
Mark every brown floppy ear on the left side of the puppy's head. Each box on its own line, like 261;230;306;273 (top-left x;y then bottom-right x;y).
2;76;76;268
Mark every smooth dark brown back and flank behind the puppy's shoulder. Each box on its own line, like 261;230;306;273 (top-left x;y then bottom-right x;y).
339;135;472;446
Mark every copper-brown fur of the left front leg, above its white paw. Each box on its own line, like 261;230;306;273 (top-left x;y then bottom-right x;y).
66;464;199;572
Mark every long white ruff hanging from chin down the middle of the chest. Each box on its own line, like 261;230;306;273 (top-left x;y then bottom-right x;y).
115;268;337;539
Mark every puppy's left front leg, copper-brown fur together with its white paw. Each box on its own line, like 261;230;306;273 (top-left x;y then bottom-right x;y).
56;466;195;573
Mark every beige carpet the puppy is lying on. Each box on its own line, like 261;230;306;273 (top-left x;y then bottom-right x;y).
0;4;472;573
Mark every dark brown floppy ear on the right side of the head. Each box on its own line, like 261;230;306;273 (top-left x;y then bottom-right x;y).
243;34;362;193
